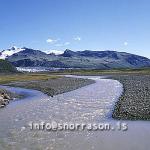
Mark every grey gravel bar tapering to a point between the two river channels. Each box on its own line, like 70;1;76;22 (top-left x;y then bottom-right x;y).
4;77;95;96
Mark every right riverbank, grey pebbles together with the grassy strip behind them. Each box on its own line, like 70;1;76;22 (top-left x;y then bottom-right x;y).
51;68;150;120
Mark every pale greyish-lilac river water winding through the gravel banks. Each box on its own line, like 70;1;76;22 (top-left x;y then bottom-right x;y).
0;76;150;150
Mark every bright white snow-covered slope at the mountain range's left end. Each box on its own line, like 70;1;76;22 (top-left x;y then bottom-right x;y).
0;46;25;59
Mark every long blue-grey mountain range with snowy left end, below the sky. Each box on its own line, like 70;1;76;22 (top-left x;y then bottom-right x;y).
0;47;150;69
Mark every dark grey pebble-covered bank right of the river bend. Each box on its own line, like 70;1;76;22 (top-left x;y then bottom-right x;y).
112;75;150;120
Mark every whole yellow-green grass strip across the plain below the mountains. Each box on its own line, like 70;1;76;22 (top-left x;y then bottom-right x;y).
0;68;150;84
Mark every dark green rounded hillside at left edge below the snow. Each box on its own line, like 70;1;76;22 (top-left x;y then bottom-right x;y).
0;59;17;73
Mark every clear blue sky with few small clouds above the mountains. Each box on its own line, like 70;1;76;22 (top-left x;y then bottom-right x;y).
0;0;150;58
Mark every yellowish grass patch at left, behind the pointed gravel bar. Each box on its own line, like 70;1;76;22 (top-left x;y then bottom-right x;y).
0;73;60;84
